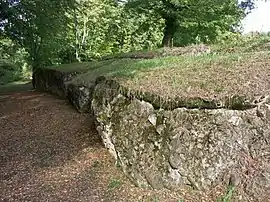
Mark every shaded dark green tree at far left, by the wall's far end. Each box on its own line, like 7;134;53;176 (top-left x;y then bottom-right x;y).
0;0;74;69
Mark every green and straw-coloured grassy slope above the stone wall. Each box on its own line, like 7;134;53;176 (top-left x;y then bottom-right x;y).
46;37;270;98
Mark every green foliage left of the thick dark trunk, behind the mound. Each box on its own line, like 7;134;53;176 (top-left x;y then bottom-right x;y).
2;0;163;64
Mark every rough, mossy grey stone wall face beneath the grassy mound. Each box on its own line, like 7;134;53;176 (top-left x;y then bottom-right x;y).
37;67;270;199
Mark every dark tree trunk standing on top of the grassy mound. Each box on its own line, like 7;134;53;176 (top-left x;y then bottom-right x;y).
162;18;176;47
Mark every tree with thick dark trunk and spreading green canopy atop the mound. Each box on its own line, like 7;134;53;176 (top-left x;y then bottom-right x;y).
126;0;255;47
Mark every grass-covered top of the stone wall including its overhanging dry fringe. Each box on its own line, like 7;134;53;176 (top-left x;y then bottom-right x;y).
40;40;270;108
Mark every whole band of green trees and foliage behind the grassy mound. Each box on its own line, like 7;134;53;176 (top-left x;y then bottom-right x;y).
0;0;260;71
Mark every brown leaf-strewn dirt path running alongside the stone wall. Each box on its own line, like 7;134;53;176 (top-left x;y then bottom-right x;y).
0;92;230;202
